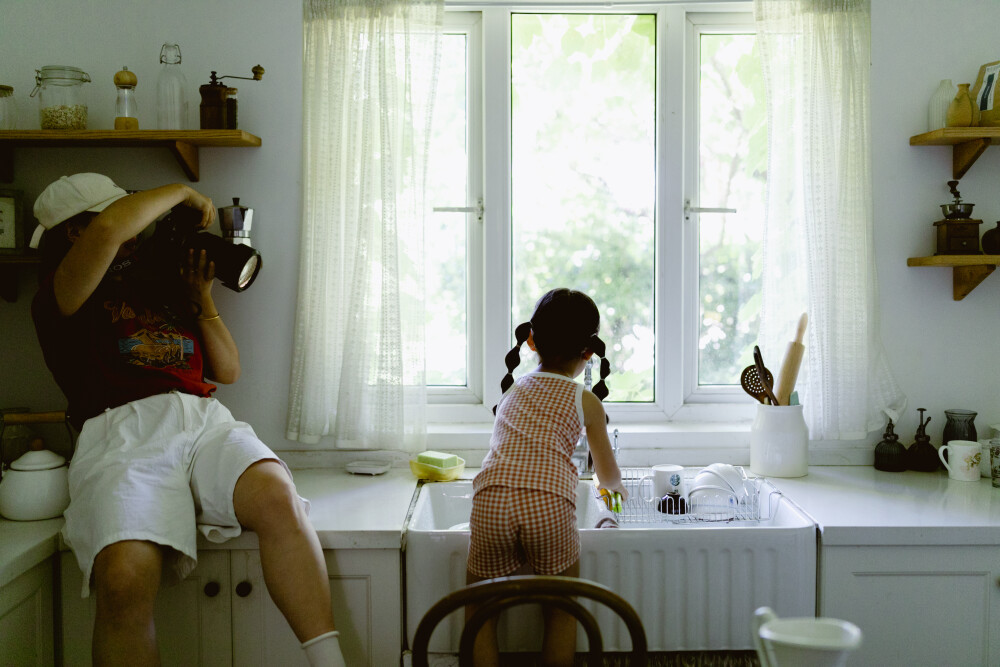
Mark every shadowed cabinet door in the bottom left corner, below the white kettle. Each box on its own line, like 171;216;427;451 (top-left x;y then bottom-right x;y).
0;560;55;667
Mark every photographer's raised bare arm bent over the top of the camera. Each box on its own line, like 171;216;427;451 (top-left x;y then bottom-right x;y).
53;183;215;316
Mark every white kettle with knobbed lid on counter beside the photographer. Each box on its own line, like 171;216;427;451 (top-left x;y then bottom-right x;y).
0;438;69;521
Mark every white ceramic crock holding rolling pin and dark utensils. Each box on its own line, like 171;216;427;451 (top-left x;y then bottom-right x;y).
750;403;809;477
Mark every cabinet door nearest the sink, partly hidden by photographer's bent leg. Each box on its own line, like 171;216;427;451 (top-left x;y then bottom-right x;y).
231;549;402;667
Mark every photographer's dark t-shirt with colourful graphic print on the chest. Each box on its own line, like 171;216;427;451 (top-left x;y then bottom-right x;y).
31;276;216;428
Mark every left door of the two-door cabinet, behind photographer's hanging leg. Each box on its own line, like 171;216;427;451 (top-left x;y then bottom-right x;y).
61;550;233;667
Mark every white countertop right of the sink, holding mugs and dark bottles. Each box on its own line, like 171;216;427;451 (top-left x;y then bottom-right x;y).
768;466;1000;546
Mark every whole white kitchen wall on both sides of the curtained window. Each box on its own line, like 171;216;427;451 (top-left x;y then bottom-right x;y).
0;0;1000;460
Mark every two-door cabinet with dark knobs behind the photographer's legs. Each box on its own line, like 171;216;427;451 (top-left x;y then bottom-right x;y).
62;549;402;667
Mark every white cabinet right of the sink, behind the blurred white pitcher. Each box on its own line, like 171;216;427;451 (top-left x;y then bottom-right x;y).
820;546;1000;666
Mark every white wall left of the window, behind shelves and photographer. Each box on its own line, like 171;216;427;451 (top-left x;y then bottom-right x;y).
0;0;302;449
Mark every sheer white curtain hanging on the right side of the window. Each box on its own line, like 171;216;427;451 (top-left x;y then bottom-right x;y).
754;0;906;440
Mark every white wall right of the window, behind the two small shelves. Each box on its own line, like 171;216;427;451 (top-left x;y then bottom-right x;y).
871;0;1000;445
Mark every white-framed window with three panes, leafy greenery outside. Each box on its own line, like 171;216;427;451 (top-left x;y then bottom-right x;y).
426;5;767;421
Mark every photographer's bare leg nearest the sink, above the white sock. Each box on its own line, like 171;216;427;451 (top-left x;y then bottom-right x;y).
233;460;334;642
